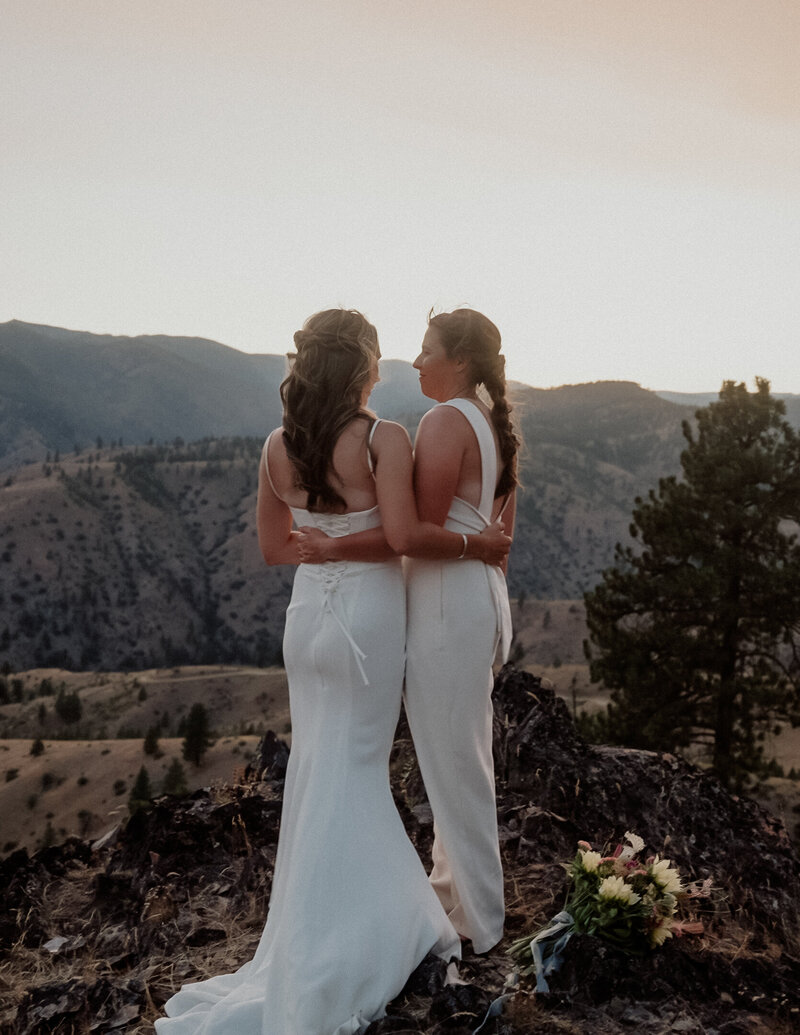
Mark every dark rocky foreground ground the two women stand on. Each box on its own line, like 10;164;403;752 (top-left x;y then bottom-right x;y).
0;668;800;1035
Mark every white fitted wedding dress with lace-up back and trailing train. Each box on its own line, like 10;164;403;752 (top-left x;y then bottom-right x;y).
155;507;461;1035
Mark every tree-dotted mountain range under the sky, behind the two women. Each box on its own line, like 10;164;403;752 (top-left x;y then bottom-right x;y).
0;321;800;669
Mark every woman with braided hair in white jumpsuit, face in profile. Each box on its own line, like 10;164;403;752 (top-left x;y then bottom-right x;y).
406;309;518;952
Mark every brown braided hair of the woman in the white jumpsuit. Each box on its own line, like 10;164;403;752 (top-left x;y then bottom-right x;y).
427;308;521;498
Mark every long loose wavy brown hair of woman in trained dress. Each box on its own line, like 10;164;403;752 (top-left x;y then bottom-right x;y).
280;309;378;511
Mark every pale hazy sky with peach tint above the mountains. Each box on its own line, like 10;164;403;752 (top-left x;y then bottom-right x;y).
0;0;800;392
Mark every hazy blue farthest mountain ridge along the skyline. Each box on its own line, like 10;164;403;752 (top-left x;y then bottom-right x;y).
0;320;800;469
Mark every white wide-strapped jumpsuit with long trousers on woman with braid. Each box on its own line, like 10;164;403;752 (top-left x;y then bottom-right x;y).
406;398;511;952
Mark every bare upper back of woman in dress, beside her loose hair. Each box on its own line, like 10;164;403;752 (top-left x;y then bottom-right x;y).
266;409;378;512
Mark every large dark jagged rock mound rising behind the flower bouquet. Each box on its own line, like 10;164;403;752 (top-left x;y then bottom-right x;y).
495;667;800;946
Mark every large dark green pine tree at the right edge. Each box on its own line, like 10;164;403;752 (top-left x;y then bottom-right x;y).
586;379;800;786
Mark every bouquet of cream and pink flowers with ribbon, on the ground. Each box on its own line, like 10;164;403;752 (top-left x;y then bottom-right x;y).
508;833;711;992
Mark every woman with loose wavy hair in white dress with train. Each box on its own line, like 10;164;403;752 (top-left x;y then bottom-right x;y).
155;309;508;1035
